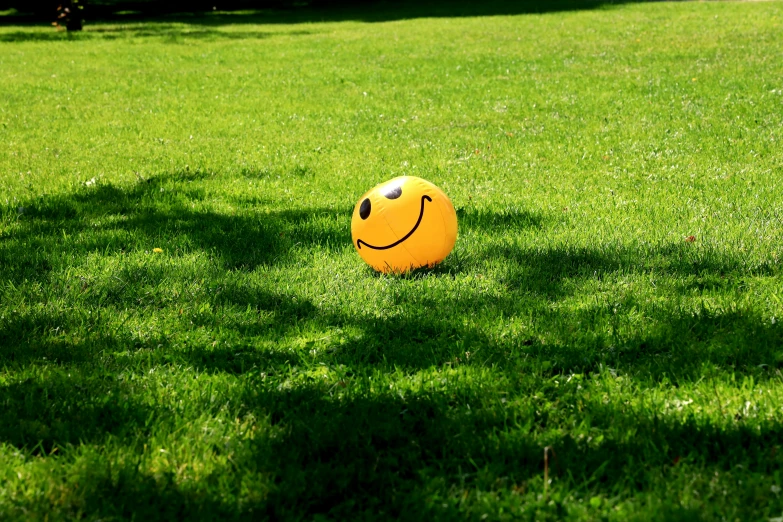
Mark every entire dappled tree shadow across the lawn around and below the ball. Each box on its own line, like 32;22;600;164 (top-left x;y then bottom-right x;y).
0;173;783;520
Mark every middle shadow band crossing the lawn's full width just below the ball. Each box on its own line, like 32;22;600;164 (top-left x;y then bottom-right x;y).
0;291;783;383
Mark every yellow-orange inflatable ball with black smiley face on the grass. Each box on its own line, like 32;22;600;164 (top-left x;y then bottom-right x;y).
351;176;457;273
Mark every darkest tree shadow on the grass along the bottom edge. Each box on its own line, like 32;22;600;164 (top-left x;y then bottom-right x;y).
15;385;783;520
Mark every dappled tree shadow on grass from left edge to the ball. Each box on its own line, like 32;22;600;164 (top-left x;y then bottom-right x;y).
0;171;350;282
